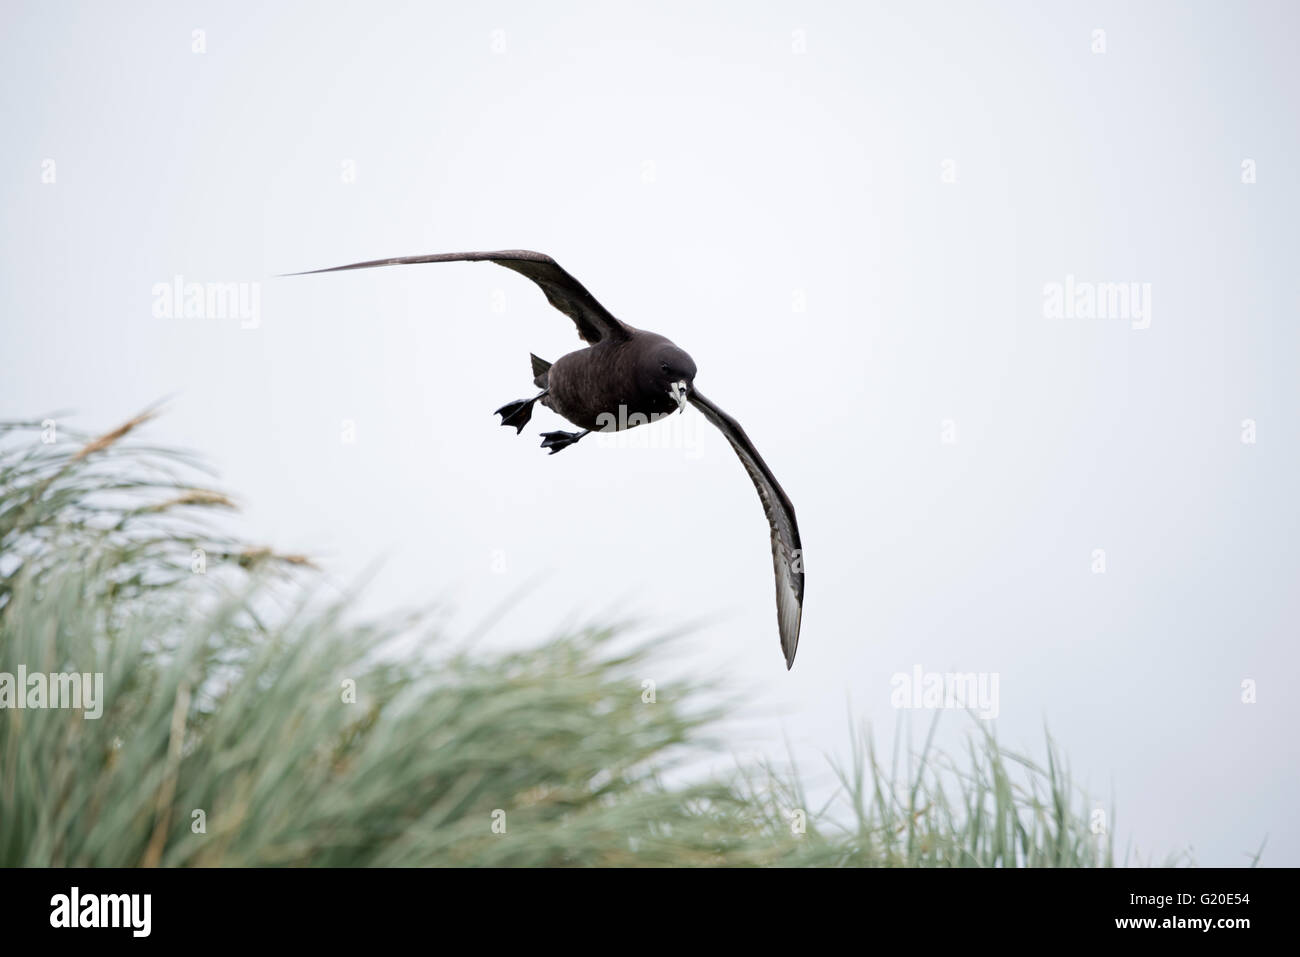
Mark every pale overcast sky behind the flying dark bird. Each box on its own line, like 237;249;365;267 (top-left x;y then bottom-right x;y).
0;0;1300;865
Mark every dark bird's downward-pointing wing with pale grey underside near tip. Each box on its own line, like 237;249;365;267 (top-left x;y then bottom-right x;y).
690;390;803;668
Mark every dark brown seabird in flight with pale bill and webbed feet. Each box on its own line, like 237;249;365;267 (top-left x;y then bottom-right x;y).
293;250;803;668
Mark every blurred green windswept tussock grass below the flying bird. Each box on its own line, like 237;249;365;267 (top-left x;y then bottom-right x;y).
0;412;1114;867
